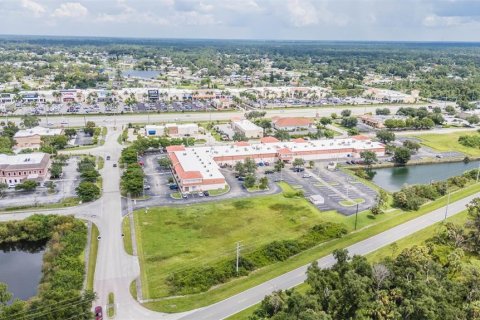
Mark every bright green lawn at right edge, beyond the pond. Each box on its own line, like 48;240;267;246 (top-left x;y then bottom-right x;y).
414;131;480;156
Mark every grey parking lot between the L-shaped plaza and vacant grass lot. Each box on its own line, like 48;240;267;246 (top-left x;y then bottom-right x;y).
134;153;377;215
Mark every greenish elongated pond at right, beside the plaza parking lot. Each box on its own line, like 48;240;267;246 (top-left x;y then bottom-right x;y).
372;161;479;192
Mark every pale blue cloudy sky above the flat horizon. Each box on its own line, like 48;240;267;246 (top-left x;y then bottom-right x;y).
0;0;480;41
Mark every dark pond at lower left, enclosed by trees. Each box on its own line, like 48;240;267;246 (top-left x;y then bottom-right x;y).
0;241;46;300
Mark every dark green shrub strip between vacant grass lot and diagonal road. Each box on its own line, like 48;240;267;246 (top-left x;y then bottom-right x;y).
167;222;347;295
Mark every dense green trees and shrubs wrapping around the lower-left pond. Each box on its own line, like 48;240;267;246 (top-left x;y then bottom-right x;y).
0;215;95;320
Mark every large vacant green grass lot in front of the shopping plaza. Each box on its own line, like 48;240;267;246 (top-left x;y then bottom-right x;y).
134;190;330;299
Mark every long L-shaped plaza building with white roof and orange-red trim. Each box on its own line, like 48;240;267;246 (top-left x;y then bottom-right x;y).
167;136;385;192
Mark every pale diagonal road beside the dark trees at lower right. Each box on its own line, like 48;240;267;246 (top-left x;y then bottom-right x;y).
180;194;480;320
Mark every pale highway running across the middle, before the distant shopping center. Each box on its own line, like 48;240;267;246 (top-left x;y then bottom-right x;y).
3;104;427;126
